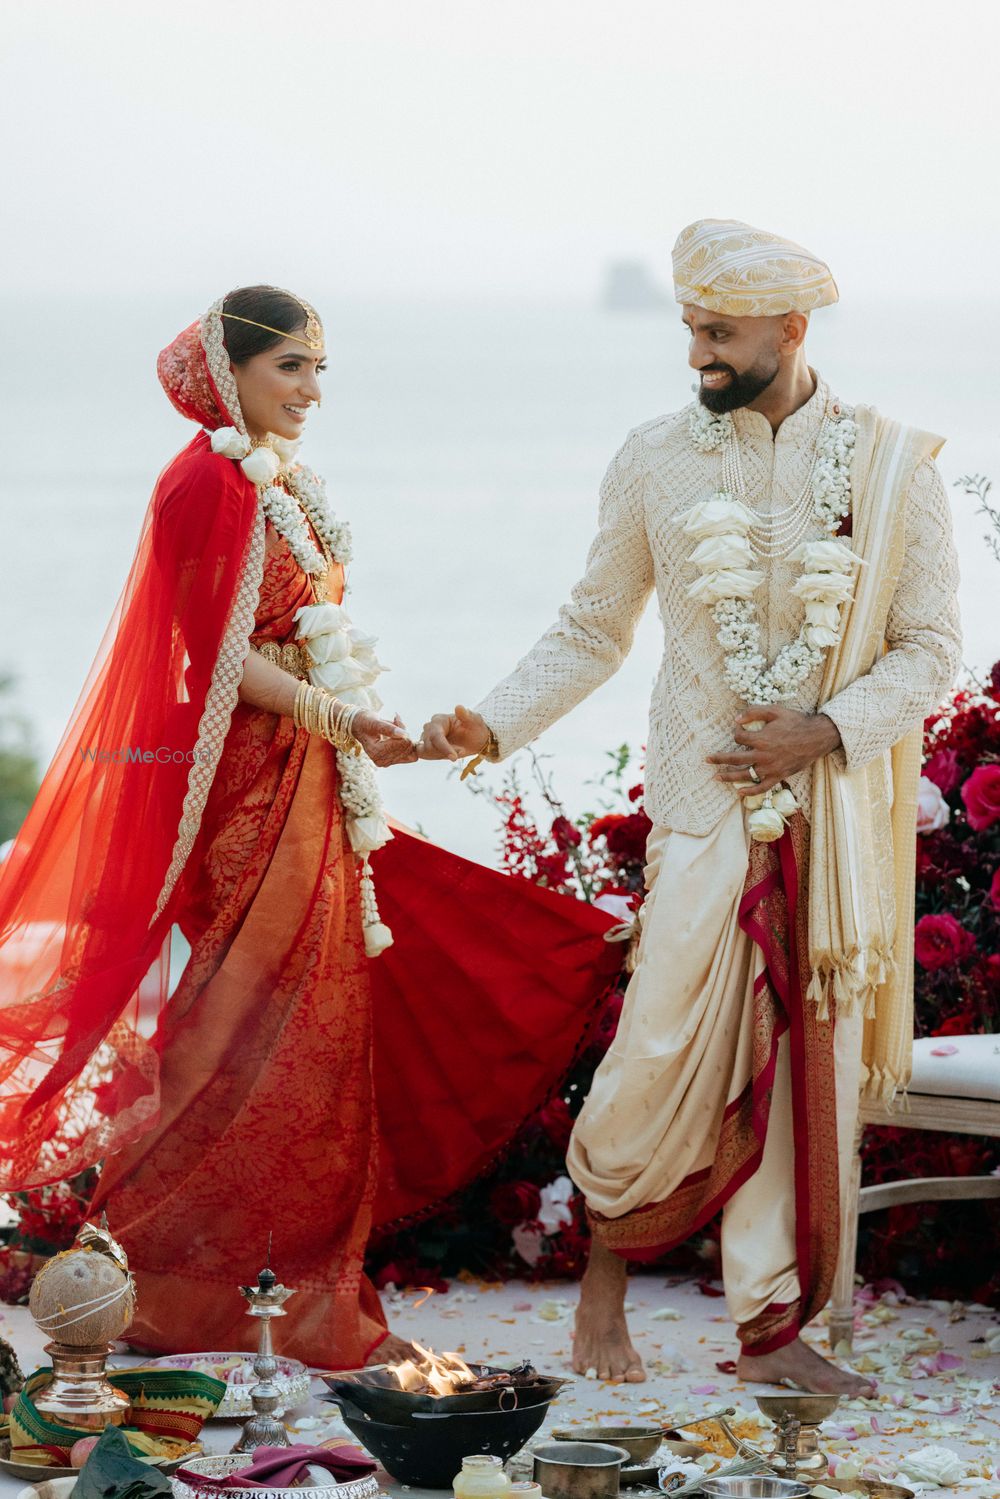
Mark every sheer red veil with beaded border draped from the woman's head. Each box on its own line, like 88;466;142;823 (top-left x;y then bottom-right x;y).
0;301;264;1189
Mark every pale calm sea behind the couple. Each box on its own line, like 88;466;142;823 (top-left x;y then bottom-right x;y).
0;288;1000;862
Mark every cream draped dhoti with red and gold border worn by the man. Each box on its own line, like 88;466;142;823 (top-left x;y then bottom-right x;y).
568;802;862;1354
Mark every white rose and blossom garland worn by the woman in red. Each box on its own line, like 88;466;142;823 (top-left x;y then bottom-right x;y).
211;427;393;956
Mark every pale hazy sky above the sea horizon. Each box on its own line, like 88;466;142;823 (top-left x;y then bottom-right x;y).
0;0;1000;306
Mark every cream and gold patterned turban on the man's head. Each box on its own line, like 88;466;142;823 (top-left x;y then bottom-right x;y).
673;219;838;318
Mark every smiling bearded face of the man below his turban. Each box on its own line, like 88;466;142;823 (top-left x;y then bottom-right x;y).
684;303;786;414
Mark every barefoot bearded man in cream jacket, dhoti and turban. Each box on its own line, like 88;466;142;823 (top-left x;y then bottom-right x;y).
420;219;960;1393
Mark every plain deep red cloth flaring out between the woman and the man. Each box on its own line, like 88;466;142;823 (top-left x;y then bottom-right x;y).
370;829;624;1226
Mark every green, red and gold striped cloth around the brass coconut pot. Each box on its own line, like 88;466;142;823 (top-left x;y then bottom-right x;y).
0;1369;226;1468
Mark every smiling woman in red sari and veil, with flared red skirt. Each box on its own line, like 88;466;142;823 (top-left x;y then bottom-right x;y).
0;286;616;1367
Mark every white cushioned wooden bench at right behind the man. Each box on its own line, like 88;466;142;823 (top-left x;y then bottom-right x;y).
829;1036;1000;1348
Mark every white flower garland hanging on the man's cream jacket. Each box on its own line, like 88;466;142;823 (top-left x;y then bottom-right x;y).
689;405;861;842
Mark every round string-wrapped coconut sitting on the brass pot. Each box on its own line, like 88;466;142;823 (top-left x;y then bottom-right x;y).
28;1247;135;1348
